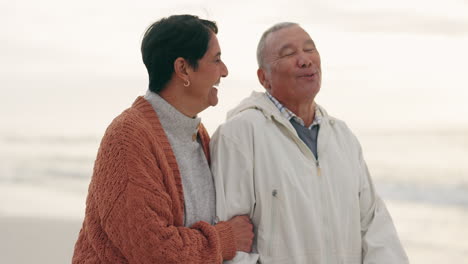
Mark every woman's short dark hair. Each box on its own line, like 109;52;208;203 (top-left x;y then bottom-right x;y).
141;15;218;93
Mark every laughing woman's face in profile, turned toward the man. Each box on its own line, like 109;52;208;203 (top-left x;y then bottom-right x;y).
186;34;228;108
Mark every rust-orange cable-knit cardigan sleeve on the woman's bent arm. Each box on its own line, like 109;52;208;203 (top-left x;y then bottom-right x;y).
95;136;235;264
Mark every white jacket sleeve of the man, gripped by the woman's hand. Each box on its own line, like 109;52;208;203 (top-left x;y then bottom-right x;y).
210;127;258;264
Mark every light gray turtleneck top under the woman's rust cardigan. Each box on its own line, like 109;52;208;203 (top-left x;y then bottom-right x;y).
144;90;216;227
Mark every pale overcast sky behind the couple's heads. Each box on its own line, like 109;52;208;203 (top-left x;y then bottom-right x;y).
0;0;468;133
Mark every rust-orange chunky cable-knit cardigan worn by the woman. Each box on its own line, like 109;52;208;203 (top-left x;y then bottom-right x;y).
72;97;235;264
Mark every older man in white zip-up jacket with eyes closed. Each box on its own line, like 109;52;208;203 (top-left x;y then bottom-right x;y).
210;23;408;264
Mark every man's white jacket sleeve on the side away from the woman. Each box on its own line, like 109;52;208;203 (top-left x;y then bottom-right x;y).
359;144;409;264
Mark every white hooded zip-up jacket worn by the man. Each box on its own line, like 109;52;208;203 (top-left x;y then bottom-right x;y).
210;92;408;264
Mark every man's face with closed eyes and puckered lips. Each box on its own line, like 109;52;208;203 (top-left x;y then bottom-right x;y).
258;26;322;106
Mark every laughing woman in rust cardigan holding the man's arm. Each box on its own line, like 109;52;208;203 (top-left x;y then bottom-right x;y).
73;15;253;263
